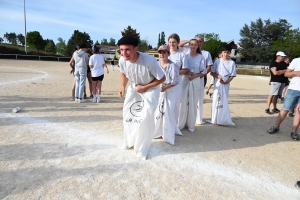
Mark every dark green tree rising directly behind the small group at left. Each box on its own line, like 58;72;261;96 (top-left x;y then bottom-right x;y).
66;30;93;56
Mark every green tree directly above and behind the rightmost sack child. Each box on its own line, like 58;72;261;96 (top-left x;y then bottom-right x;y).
195;33;226;58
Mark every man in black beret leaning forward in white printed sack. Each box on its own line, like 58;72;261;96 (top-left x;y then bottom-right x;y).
118;36;166;159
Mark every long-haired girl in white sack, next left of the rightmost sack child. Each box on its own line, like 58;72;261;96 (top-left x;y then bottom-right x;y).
178;39;206;132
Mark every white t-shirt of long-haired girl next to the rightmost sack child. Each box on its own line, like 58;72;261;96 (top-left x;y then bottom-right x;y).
185;54;206;74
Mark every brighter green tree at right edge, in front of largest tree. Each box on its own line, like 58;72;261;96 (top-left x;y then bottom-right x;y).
272;28;300;58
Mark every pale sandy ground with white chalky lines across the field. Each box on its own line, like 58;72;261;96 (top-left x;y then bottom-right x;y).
0;60;300;199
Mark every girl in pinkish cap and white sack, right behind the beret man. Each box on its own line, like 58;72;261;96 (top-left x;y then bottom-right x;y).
154;45;179;145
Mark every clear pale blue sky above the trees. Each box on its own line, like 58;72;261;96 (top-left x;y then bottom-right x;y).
0;0;300;47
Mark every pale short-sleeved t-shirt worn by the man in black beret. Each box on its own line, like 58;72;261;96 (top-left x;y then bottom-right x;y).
119;52;165;85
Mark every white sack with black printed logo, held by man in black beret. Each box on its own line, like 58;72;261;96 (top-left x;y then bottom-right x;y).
122;84;160;159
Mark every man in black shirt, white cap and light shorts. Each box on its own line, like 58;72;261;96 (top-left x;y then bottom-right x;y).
265;51;287;114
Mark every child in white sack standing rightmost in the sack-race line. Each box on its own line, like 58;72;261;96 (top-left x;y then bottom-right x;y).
210;44;236;126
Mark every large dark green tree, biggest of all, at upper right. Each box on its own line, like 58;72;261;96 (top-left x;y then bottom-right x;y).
239;18;291;62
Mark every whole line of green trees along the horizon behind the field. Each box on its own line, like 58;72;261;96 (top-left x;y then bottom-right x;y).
0;18;300;62
